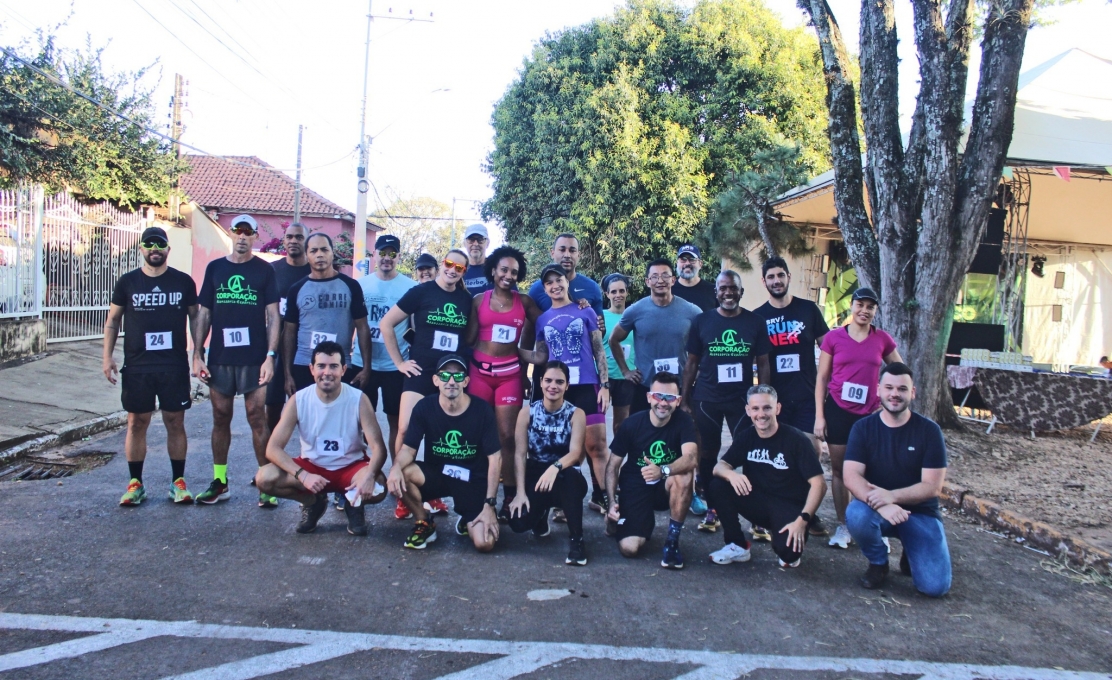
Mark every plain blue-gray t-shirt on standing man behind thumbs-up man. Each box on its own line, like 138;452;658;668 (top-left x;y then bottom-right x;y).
619;297;703;382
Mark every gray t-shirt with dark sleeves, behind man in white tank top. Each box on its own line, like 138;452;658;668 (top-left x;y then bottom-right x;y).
285;274;367;366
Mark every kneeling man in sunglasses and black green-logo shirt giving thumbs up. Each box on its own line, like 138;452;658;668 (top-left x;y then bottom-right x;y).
606;372;698;569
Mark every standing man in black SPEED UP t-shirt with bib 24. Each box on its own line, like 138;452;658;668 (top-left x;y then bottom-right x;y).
102;227;198;506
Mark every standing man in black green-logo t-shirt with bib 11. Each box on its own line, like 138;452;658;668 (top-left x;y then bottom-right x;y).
683;269;770;532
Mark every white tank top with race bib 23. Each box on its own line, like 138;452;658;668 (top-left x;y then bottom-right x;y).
295;384;366;470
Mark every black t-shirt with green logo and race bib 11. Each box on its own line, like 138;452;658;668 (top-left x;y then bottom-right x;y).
687;309;772;402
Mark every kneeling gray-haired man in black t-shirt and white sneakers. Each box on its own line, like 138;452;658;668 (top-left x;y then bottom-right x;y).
711;384;826;569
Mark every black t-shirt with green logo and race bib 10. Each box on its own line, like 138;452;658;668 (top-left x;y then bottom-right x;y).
198;257;278;366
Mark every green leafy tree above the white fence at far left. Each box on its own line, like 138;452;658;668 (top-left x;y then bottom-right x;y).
0;36;183;207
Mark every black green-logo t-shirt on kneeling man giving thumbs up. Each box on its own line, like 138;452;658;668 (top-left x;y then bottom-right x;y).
610;409;695;486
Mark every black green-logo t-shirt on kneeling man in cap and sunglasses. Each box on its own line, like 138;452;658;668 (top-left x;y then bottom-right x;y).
404;393;502;486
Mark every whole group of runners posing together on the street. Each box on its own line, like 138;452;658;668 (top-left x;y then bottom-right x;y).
103;214;951;596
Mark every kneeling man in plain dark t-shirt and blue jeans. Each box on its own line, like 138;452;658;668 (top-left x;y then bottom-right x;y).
843;361;951;598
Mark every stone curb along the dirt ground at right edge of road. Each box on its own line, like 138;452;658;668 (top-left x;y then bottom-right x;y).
940;482;1112;573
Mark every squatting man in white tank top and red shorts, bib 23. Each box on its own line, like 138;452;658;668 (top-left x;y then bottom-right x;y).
255;341;386;536
